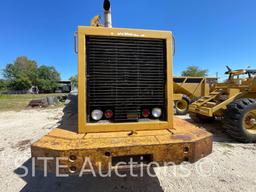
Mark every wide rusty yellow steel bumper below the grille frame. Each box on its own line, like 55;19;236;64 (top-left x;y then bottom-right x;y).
31;118;212;174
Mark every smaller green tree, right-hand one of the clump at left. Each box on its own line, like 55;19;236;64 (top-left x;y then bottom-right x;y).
36;65;60;92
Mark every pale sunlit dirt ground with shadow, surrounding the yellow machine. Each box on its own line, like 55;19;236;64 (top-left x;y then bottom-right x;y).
0;98;256;192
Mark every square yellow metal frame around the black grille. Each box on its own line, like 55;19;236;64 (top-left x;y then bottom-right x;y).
78;26;173;133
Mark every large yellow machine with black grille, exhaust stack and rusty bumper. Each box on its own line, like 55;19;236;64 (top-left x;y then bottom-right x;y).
31;1;212;174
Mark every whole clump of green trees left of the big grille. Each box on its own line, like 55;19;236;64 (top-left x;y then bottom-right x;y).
0;56;60;92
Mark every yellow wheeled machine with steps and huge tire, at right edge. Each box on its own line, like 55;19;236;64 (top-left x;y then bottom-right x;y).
189;67;256;143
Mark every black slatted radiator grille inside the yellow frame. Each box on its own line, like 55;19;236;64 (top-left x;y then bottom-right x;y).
86;36;167;122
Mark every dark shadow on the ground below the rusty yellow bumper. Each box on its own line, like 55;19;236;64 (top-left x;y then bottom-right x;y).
15;159;163;192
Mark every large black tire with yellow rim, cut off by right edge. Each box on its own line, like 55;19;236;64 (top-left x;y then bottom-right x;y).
223;98;256;143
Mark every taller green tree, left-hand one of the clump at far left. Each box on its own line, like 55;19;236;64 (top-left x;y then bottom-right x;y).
3;56;37;90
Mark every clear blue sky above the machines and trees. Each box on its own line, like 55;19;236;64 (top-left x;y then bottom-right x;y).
0;0;256;80
